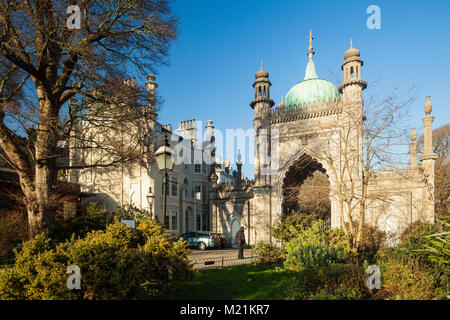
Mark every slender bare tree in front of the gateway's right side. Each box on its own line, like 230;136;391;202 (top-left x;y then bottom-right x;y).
312;92;414;251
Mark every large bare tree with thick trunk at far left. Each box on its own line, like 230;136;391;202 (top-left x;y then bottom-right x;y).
0;0;177;236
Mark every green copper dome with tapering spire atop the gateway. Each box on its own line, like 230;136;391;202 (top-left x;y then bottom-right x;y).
284;55;339;106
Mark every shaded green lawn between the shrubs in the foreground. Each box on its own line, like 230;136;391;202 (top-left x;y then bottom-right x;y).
171;264;296;300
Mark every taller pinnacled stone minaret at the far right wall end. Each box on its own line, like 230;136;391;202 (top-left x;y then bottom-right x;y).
420;96;436;222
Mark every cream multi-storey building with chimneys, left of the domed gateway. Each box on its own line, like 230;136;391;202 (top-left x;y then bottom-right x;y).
69;76;214;234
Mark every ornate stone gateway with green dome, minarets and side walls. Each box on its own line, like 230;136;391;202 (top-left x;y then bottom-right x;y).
211;34;436;243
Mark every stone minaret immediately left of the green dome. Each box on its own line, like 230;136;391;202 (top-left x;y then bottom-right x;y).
250;62;275;186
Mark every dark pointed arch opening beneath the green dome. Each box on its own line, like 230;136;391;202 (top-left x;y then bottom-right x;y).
282;154;331;224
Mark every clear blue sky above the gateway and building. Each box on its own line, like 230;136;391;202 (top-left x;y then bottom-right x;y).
149;0;450;176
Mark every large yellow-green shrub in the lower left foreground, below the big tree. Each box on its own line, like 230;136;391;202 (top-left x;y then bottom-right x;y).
0;221;191;299
